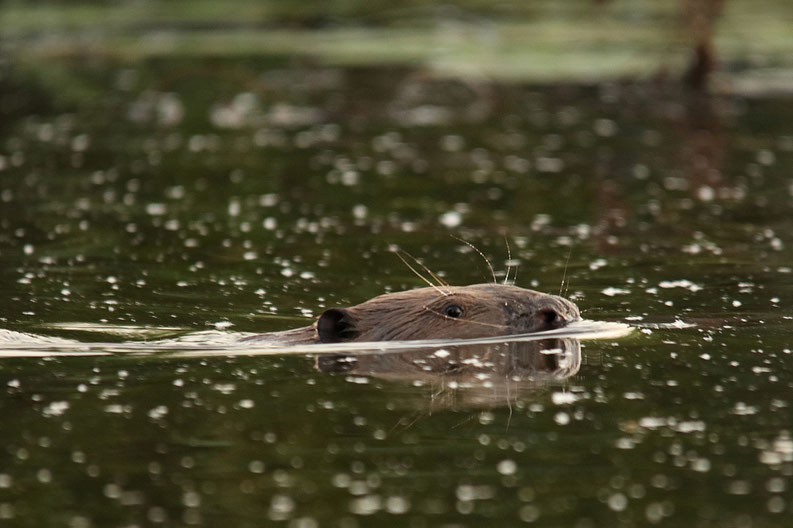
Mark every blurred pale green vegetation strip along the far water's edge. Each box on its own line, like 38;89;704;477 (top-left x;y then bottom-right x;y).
0;0;793;91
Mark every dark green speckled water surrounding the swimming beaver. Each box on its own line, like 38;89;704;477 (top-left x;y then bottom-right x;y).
0;49;793;528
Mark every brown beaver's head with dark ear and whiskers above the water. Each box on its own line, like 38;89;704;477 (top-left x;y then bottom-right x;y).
247;284;580;345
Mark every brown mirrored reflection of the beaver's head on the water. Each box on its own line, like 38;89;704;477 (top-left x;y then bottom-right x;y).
316;339;581;409
